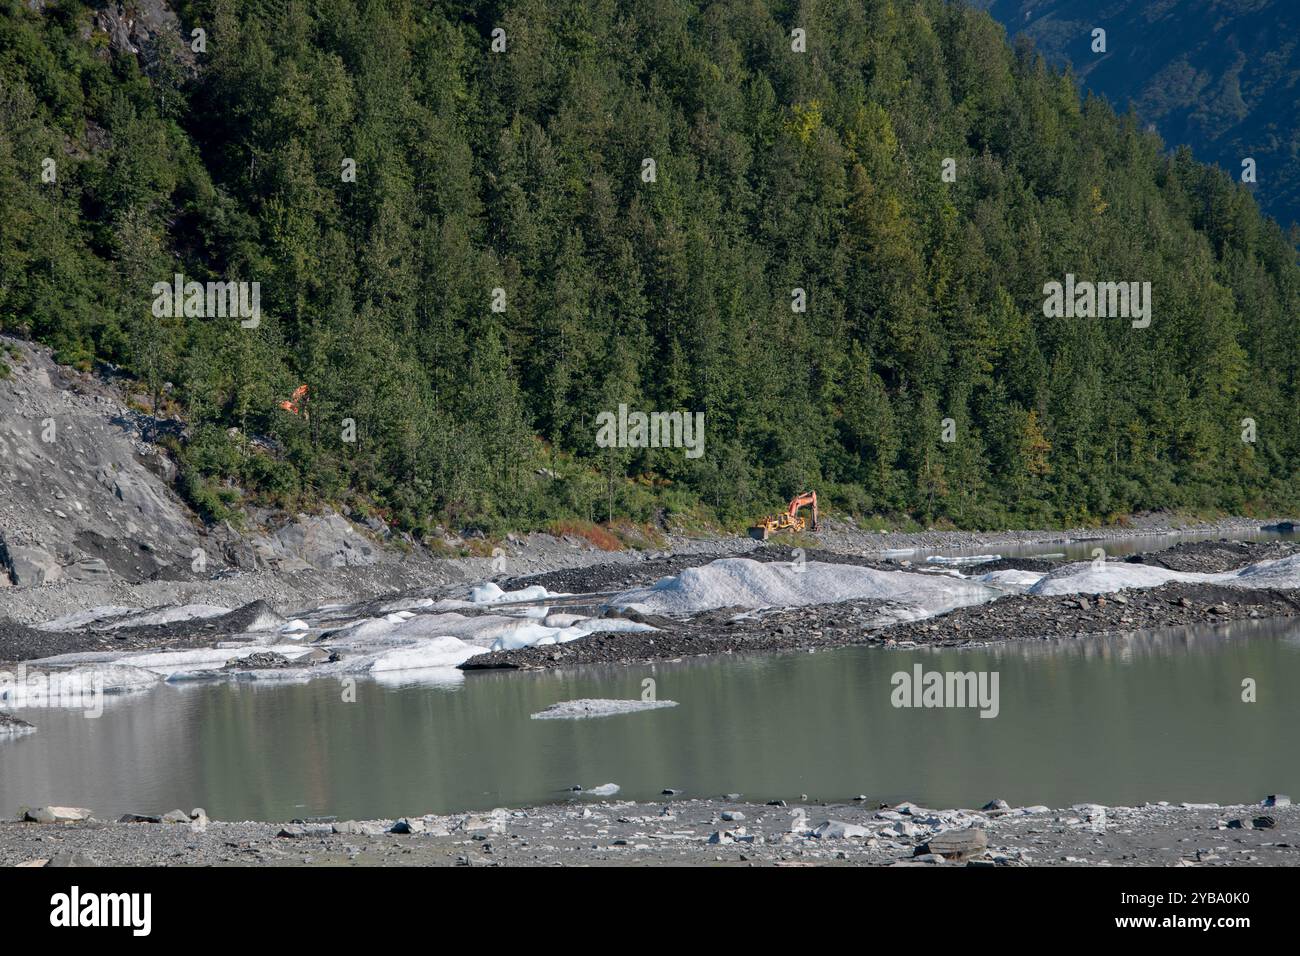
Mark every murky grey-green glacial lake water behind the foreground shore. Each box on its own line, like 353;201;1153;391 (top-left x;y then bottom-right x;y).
0;620;1300;821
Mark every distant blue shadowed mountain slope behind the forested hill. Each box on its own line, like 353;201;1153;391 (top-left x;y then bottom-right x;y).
972;0;1300;225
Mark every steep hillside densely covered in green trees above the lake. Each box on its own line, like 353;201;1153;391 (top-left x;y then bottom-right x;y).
0;0;1300;531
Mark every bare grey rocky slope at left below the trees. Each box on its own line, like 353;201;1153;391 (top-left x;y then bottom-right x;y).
0;337;391;588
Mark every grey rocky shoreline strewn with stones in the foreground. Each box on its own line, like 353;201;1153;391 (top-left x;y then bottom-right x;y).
0;795;1300;866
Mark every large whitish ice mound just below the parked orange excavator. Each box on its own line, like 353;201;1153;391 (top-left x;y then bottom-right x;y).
611;558;1001;618
